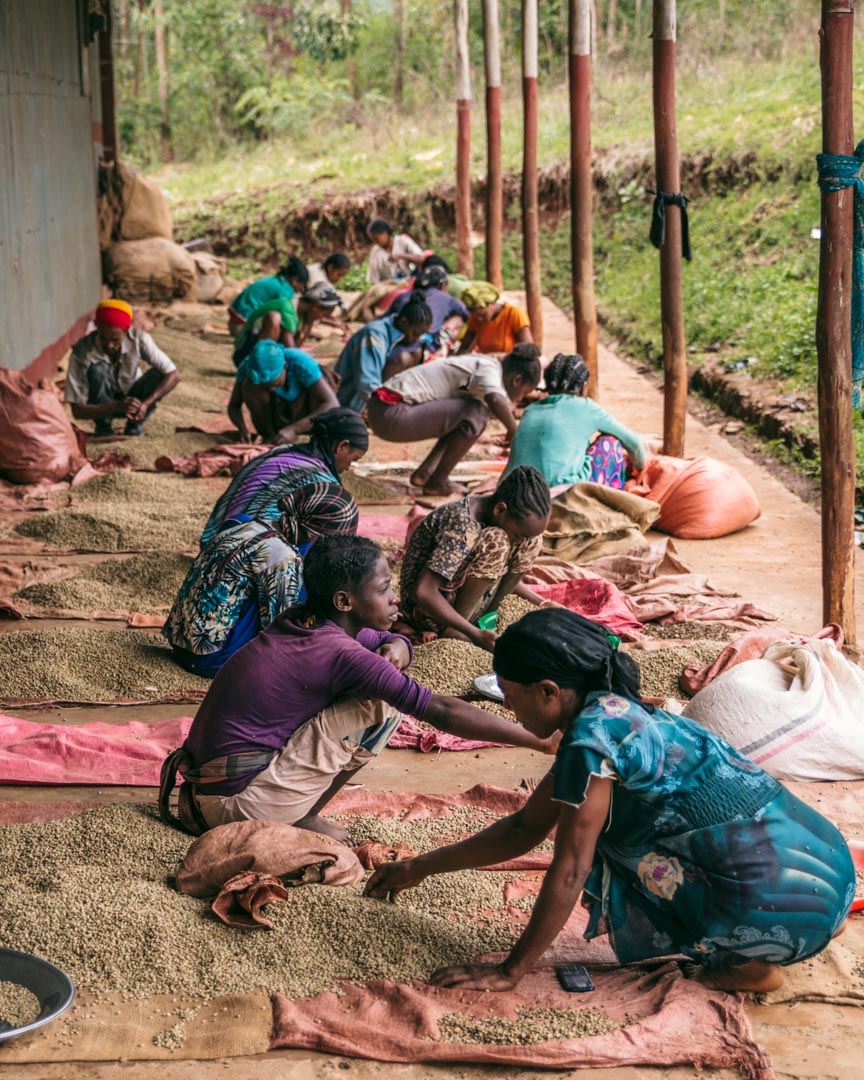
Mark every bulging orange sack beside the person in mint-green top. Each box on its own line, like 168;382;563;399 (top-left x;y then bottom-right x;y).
627;455;762;540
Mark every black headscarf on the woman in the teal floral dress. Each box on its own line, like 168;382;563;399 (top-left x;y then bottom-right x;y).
492;608;642;701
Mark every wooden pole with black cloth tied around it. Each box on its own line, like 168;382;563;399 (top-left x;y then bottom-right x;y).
653;0;687;458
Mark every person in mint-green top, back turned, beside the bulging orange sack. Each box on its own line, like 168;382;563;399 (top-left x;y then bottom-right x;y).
504;353;645;488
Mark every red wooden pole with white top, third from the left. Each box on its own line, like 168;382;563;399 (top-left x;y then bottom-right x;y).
522;0;543;349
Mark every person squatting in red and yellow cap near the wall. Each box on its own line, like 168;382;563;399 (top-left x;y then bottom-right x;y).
64;300;180;435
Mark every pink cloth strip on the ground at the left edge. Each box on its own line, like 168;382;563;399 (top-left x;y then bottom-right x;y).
0;716;192;787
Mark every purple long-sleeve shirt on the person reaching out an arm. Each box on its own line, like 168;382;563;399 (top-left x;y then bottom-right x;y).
186;612;432;795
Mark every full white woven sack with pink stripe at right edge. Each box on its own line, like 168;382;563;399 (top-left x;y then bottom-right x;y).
684;638;864;781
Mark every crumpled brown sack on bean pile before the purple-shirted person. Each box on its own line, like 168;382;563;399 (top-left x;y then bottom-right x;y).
177;821;363;896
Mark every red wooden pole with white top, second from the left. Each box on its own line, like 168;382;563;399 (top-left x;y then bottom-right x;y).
483;0;504;288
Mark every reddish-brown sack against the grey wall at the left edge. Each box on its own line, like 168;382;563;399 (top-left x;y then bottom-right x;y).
0;370;84;484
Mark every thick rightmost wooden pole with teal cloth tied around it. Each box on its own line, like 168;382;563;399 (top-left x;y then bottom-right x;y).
816;0;856;645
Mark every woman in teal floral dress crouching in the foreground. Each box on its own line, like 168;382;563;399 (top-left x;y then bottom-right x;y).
366;608;855;993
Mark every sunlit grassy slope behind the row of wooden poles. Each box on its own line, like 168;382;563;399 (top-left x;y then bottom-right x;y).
161;46;864;481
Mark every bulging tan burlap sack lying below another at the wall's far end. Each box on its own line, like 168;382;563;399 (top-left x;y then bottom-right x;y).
104;237;197;303
